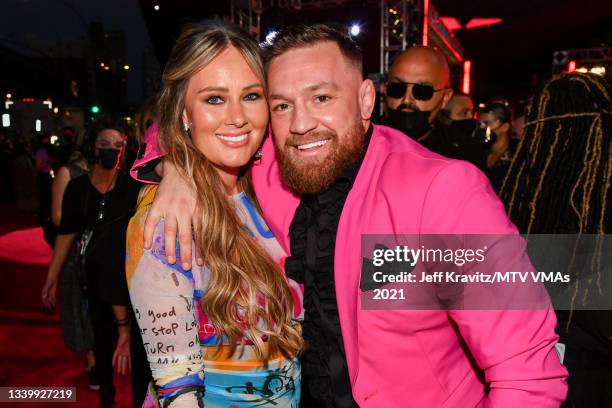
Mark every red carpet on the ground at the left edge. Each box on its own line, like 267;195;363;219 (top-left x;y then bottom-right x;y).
0;206;132;408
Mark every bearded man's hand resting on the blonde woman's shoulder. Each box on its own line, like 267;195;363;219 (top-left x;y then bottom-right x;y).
144;162;202;270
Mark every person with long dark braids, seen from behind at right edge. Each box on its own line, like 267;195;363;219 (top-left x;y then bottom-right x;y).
501;73;612;408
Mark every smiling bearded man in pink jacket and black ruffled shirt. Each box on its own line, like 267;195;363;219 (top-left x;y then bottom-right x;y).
131;24;567;407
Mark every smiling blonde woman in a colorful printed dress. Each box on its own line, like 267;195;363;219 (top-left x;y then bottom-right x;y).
126;21;302;408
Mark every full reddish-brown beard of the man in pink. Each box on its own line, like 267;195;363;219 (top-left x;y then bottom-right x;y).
274;122;365;194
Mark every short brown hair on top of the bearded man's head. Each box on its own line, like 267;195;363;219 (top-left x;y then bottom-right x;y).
263;24;363;72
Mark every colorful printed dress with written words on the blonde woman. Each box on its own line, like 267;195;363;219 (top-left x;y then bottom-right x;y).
126;187;303;408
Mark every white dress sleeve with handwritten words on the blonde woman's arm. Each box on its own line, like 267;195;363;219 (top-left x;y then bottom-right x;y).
128;221;204;407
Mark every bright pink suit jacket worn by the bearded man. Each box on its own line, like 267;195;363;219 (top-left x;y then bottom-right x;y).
132;125;567;408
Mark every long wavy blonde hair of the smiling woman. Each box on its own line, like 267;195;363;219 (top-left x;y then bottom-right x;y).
159;20;302;359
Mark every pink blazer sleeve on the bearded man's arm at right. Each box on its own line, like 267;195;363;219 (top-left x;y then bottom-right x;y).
422;162;568;408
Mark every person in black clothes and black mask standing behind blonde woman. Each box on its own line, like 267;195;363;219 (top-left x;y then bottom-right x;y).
42;118;147;408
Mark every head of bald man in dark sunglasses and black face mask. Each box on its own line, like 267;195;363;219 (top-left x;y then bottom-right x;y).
383;47;453;142
